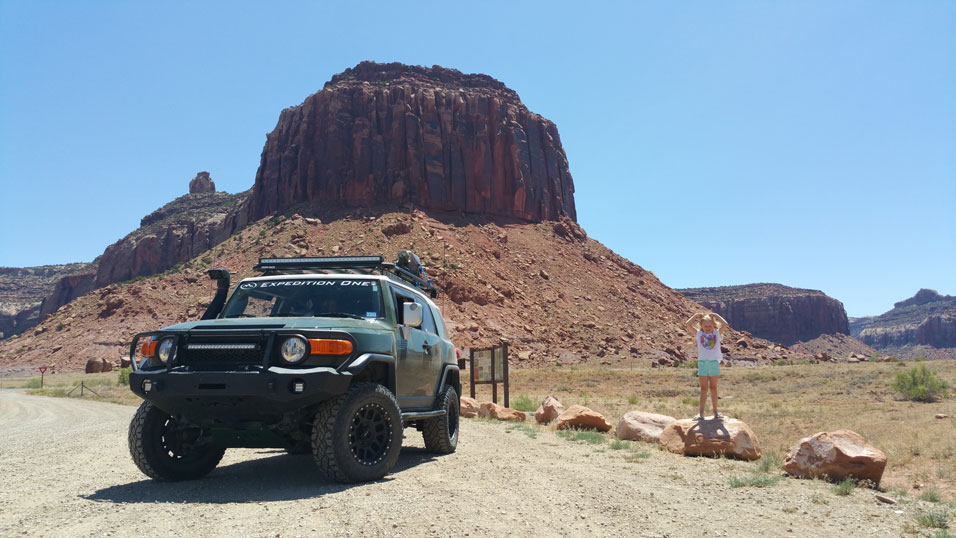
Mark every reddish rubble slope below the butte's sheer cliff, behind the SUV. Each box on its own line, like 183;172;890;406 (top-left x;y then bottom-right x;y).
0;210;792;370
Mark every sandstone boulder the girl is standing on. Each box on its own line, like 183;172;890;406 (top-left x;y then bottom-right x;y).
660;418;760;460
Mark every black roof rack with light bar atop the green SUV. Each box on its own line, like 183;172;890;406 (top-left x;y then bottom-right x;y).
253;256;438;298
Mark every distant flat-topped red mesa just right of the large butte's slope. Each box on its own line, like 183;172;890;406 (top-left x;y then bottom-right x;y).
679;284;850;345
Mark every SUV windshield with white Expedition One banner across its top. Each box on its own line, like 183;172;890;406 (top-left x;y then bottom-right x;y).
223;278;385;319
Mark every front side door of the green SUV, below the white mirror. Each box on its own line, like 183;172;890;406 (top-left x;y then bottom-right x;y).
390;286;434;410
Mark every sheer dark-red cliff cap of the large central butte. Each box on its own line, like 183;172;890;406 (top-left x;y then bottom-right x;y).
250;62;575;221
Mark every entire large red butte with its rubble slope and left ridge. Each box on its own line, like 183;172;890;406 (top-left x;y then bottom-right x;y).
0;62;812;369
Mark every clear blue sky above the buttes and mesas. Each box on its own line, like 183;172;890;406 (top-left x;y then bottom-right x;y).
0;0;956;316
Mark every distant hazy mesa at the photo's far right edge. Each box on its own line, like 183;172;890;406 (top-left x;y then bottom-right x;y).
857;289;956;356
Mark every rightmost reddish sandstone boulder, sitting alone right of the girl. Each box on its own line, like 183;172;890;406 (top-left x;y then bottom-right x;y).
783;430;886;484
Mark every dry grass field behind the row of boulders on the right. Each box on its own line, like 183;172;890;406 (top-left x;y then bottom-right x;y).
474;361;956;498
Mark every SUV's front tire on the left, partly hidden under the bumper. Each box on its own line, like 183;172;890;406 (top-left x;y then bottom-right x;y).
129;402;226;482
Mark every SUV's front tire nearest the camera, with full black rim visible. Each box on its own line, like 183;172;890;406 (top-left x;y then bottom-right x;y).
312;383;403;482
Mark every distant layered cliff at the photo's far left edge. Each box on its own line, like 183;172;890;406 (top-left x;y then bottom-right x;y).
0;263;90;338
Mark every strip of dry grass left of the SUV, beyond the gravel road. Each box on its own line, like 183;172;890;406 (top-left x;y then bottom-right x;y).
0;370;142;405
